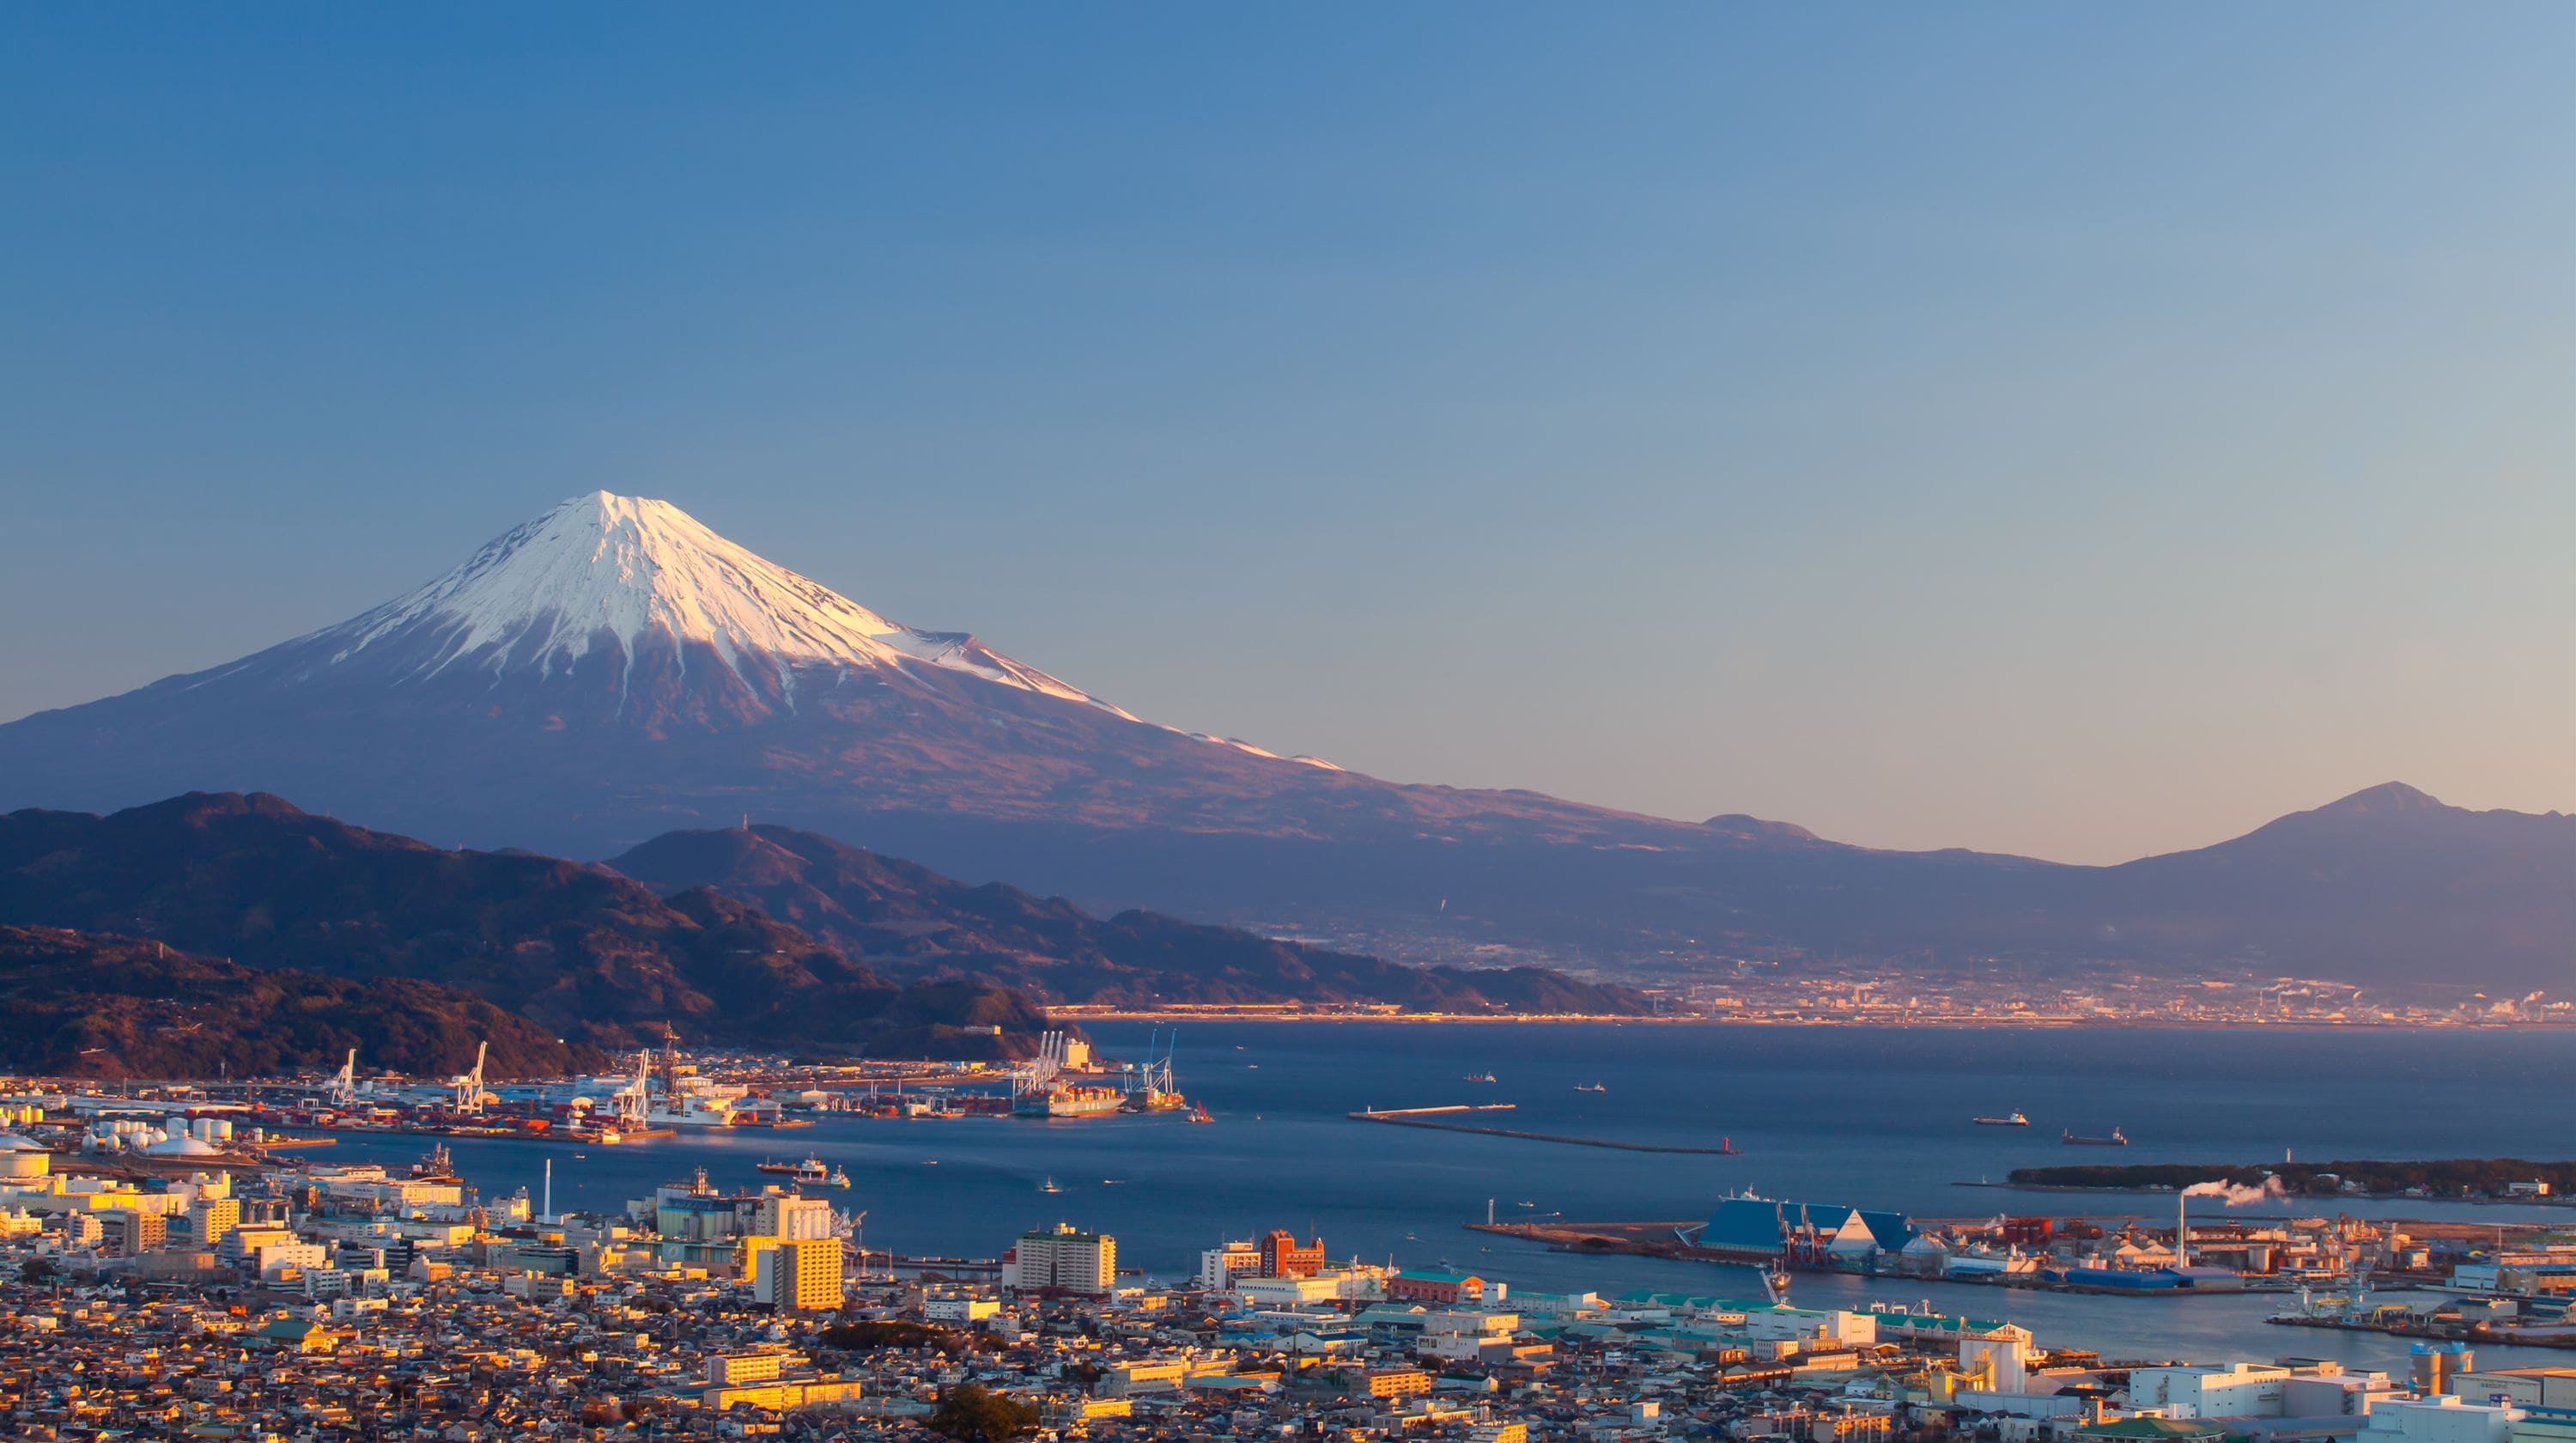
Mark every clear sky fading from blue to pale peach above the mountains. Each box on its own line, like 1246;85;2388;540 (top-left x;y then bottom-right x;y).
0;3;2576;861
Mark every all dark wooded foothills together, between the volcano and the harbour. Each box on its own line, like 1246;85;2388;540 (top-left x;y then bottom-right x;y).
0;794;1646;1072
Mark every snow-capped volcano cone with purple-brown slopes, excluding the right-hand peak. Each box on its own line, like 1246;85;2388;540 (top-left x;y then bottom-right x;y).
0;492;1682;855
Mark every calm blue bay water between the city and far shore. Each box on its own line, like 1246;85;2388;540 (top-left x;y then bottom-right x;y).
330;1023;2576;1368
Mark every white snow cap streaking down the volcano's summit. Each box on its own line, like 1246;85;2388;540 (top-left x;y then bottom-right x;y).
312;492;1133;722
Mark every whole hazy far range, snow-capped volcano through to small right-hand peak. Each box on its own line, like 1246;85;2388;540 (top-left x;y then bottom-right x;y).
0;492;2576;992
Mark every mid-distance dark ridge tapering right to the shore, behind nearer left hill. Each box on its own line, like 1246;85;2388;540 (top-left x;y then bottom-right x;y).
608;825;1649;1015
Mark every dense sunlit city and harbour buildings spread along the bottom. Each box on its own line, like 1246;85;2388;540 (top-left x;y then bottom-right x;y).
0;1044;2576;1443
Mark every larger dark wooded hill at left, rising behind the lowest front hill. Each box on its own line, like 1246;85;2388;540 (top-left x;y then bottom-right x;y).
0;794;1043;1056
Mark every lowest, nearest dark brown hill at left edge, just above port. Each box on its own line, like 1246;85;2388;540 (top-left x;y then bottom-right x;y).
0;928;608;1080
